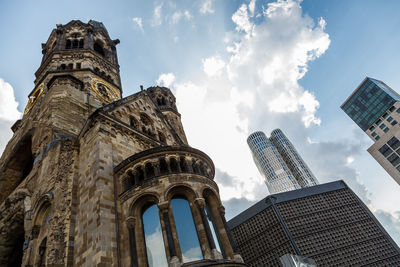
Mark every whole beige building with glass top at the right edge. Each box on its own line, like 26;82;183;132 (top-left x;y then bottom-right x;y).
341;77;400;184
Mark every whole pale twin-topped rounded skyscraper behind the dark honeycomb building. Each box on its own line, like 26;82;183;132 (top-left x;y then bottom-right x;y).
247;129;318;194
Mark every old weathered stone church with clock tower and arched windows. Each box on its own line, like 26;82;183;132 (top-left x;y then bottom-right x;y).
0;20;245;267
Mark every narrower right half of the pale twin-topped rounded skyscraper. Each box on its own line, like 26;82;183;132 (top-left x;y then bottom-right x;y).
270;129;318;187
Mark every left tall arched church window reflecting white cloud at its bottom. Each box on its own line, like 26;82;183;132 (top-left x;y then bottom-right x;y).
142;204;168;267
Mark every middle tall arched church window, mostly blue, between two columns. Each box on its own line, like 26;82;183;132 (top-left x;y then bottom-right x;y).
171;197;203;262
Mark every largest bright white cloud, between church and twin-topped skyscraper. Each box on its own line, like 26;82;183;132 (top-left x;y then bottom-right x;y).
174;0;332;201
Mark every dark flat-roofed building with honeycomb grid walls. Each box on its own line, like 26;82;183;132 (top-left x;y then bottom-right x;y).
228;181;400;267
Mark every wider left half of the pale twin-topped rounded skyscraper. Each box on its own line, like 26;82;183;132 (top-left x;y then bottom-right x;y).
247;132;300;194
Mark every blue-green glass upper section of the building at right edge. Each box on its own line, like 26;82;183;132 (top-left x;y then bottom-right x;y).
341;78;400;131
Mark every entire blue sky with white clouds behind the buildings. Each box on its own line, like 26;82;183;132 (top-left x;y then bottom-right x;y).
0;0;400;244
